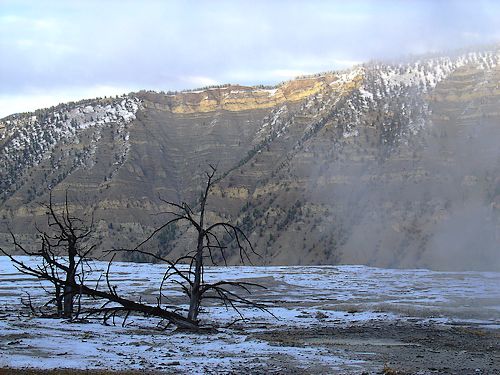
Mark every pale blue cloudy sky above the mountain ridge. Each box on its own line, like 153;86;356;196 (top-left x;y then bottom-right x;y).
0;0;500;117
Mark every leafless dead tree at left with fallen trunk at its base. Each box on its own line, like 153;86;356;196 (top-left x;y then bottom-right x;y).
0;193;197;329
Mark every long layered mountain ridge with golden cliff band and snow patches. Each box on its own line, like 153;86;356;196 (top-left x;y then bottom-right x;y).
0;49;500;269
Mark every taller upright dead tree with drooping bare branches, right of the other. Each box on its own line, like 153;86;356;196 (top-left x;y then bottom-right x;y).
116;166;272;325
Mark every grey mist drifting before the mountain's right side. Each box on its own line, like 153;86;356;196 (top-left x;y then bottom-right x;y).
308;59;500;271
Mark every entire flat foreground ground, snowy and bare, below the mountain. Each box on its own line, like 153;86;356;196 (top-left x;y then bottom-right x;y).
0;259;500;375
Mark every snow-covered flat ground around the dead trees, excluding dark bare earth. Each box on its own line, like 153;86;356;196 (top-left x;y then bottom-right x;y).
0;257;500;374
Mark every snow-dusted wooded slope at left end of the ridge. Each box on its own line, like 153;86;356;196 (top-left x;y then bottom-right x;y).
0;97;140;198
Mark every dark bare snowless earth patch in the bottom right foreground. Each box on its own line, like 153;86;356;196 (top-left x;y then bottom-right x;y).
256;322;500;374
